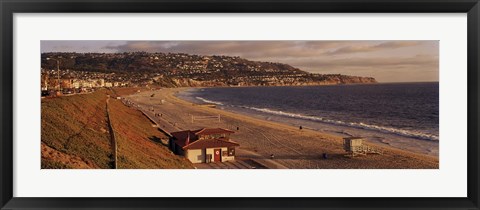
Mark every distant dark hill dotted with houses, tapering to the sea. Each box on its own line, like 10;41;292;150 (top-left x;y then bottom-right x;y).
41;52;376;87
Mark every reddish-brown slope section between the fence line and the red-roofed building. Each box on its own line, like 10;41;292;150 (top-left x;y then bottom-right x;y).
109;97;193;168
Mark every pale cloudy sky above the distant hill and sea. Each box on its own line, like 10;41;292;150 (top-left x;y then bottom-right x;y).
41;40;439;82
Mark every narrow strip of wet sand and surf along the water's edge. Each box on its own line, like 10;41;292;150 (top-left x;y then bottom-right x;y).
175;88;439;157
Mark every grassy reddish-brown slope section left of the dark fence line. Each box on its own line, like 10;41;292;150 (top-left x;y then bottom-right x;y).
41;91;112;168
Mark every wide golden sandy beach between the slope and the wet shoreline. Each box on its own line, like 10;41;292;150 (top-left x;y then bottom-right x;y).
126;88;439;169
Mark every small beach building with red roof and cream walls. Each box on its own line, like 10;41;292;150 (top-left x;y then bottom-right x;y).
169;128;239;163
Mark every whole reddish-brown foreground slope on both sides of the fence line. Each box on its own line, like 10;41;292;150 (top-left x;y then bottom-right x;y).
41;89;192;169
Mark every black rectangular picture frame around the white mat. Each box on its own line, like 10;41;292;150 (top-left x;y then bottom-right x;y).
0;0;480;209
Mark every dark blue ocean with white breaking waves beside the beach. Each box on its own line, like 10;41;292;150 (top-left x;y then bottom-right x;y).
177;83;439;156
